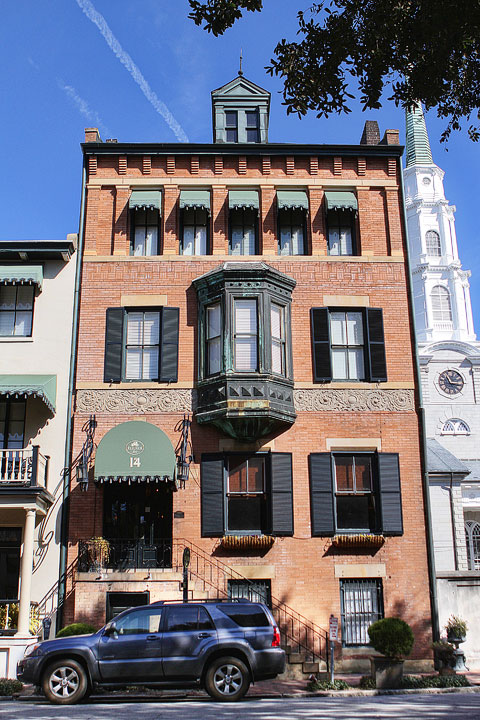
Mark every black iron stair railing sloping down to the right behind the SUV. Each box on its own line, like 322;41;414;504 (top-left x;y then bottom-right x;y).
172;539;329;667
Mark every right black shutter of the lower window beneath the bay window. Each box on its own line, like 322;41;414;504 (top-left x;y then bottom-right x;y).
270;453;293;535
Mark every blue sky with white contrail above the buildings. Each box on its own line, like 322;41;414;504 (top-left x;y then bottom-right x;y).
0;0;480;324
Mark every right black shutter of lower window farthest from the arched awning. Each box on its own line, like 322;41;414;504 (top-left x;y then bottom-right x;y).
378;453;403;535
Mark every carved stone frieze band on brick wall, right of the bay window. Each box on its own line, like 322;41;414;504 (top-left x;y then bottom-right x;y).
293;388;415;412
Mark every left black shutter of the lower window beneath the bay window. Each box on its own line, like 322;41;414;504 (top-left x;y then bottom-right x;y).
200;453;225;537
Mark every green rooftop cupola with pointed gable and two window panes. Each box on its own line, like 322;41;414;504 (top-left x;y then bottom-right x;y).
212;72;270;143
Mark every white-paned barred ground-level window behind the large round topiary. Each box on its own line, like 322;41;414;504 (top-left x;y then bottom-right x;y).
340;580;383;645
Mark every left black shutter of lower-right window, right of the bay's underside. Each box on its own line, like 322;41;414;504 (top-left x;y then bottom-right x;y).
308;453;335;537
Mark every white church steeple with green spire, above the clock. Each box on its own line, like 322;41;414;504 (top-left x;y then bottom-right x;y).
404;104;475;345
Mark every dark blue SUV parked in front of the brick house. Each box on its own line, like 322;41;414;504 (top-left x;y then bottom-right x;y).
17;600;285;705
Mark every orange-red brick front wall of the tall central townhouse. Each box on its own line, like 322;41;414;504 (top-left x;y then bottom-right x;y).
67;148;431;658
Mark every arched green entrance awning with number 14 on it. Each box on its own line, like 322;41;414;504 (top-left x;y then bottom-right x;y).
95;420;176;483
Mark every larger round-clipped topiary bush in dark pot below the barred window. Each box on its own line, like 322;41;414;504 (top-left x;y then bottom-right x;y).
368;618;415;688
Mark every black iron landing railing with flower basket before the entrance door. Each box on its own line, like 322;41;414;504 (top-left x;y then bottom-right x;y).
78;538;172;572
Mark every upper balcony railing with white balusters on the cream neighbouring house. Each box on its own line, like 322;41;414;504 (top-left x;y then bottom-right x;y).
0;445;50;489
